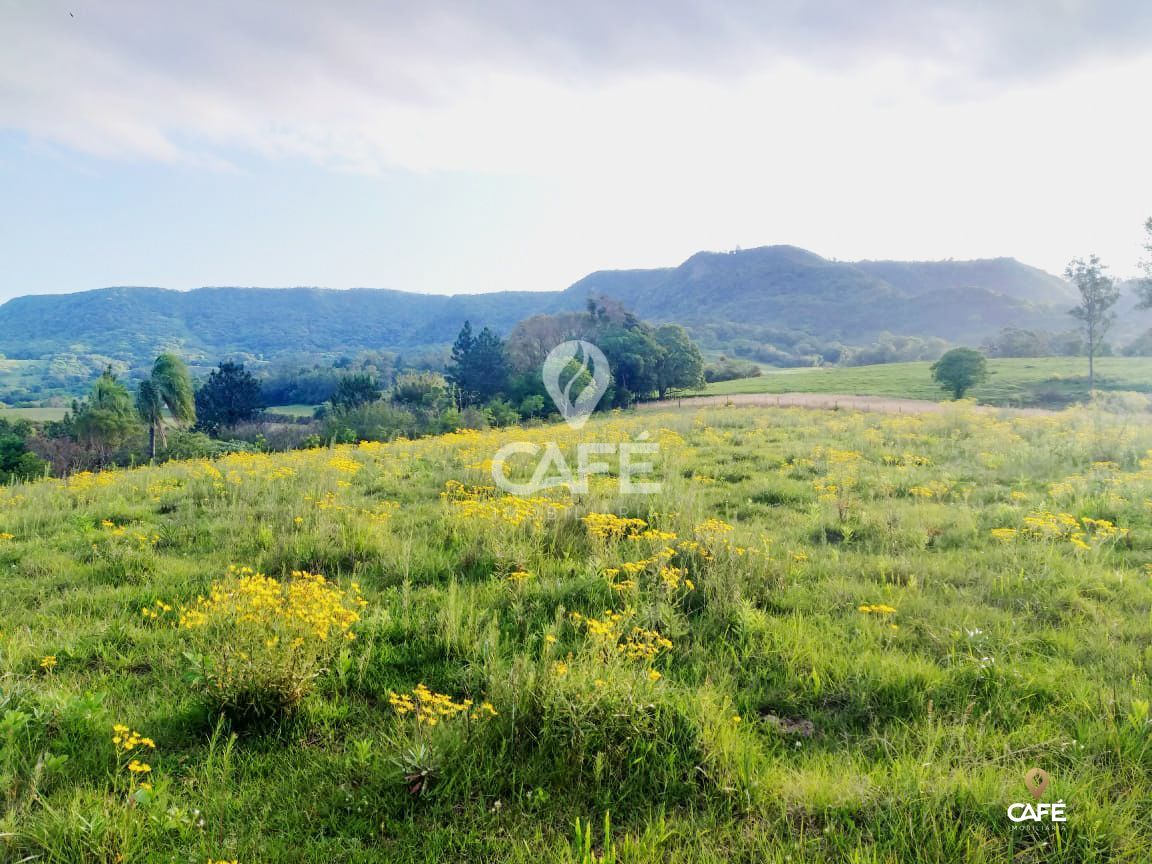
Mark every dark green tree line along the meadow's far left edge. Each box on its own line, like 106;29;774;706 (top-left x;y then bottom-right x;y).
13;301;704;480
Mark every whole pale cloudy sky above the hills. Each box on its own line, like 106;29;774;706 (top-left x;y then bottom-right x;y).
0;0;1152;300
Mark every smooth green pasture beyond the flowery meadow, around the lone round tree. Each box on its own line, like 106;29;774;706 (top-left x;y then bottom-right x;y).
705;357;1152;408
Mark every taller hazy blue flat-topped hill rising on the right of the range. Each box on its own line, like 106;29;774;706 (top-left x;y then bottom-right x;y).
566;247;1073;343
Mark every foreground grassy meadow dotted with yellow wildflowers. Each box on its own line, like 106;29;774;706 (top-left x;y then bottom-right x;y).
0;408;1152;864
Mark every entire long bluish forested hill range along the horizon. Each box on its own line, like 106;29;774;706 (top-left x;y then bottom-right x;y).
0;247;1071;363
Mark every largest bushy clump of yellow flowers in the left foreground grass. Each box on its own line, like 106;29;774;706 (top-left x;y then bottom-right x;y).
180;567;365;715
